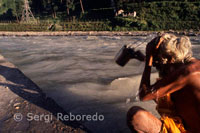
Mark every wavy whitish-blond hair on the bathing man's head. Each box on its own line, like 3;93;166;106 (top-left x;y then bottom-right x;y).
157;33;192;64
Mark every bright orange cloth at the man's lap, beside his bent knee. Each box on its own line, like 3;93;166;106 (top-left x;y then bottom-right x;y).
161;115;189;133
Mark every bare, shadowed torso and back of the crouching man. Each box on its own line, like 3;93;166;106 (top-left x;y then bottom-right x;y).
171;60;200;133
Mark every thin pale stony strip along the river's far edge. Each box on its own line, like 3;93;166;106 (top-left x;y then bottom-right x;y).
0;31;200;36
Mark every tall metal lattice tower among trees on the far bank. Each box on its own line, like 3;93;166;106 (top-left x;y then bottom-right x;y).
21;0;35;22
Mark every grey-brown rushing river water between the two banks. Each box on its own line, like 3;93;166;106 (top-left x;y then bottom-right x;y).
0;34;200;133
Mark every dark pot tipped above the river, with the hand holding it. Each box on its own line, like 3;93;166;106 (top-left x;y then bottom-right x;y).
115;45;145;66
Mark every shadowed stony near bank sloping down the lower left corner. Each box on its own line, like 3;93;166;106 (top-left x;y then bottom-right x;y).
0;55;89;133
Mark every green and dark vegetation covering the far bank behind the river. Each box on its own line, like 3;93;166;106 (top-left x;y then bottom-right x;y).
0;0;200;31
